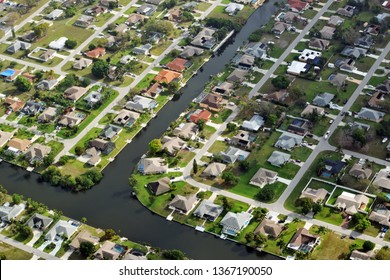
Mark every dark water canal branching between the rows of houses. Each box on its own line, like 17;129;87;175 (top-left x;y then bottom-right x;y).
0;1;284;259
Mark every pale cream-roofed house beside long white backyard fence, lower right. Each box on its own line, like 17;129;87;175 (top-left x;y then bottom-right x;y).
335;191;370;215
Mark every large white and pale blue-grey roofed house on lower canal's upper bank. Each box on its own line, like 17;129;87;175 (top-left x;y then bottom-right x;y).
220;212;253;236
